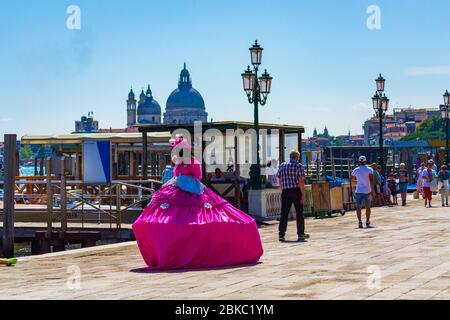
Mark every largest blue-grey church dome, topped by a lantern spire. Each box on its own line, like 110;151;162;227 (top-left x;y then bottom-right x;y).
166;64;205;111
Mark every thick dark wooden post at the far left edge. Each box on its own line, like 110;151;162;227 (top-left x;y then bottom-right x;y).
2;134;17;258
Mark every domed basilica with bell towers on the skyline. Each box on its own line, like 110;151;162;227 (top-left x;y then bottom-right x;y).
127;64;208;127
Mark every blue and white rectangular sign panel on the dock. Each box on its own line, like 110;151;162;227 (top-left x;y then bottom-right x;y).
83;141;111;184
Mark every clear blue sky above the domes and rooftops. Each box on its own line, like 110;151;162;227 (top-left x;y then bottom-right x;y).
0;0;450;136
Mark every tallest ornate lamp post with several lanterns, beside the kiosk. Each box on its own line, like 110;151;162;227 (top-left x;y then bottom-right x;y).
242;41;272;190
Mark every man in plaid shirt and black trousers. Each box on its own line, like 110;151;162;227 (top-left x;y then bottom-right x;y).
277;151;309;242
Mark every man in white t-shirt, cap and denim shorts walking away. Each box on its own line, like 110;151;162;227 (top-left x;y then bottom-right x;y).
351;156;375;229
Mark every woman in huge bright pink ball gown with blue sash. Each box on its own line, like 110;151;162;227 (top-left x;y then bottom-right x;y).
133;137;263;270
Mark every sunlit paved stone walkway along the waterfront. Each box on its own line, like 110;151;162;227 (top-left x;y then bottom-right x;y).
0;199;450;299
